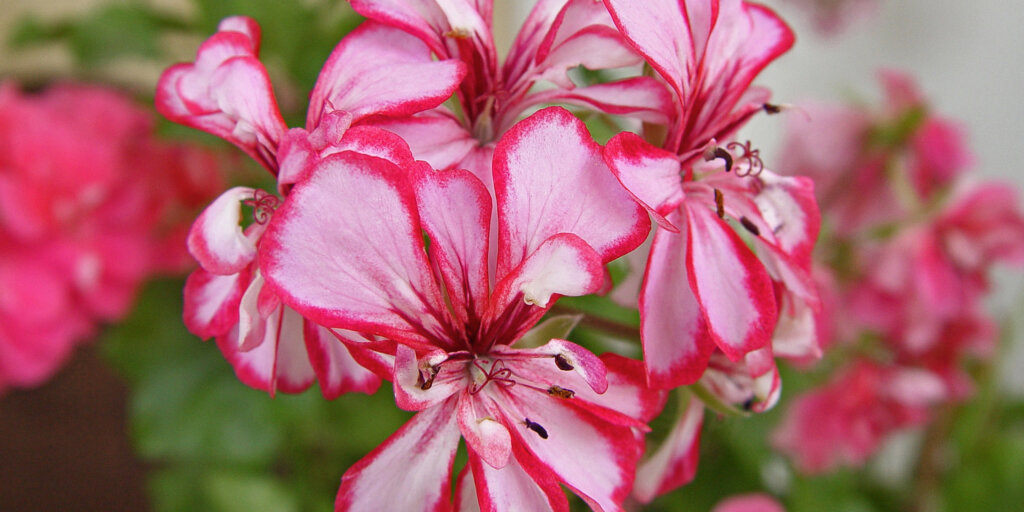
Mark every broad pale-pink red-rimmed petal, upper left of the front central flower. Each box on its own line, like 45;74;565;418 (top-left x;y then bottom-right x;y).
260;152;451;347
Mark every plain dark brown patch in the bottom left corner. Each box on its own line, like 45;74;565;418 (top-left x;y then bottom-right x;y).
0;347;148;512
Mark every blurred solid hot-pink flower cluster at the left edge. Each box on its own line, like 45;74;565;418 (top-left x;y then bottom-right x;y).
0;83;223;391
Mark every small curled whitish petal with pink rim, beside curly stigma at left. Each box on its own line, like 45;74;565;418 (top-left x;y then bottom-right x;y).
188;186;256;275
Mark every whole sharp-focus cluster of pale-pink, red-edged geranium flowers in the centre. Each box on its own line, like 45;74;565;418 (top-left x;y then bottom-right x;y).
157;0;819;511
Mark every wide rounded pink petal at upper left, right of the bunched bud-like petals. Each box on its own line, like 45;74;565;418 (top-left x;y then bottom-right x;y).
306;22;466;126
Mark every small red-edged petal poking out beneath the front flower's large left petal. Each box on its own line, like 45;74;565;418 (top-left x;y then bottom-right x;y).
303;321;381;400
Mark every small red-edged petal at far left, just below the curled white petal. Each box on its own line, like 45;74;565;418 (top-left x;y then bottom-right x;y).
183;268;249;339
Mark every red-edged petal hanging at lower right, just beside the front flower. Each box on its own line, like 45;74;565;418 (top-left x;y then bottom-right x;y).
633;396;705;503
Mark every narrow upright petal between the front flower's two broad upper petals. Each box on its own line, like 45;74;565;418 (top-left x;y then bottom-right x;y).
413;168;492;324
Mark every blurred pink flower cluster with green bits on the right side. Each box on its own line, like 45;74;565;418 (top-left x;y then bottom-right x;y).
775;72;1024;472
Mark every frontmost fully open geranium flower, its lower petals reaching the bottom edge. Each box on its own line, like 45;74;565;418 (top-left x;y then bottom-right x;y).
260;108;662;510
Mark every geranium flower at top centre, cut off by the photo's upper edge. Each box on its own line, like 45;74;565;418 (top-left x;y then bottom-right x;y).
351;0;670;188
